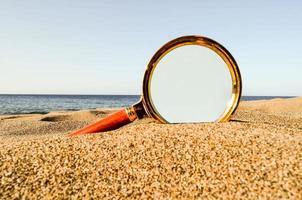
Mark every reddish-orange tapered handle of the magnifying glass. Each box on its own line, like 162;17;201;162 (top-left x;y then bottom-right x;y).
67;107;137;137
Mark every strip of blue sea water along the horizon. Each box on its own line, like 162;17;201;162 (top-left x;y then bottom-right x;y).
0;94;291;115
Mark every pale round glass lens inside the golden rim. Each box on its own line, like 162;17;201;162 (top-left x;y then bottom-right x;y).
149;45;232;123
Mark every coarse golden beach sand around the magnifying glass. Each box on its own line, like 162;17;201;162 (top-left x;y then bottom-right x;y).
0;98;302;199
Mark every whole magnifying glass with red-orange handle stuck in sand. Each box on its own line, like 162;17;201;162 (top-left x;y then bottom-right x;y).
68;36;242;136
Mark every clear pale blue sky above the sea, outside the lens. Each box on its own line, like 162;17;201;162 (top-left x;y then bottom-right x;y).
0;0;302;96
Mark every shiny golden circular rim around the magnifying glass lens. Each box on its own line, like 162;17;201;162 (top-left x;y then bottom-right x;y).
142;35;242;123
